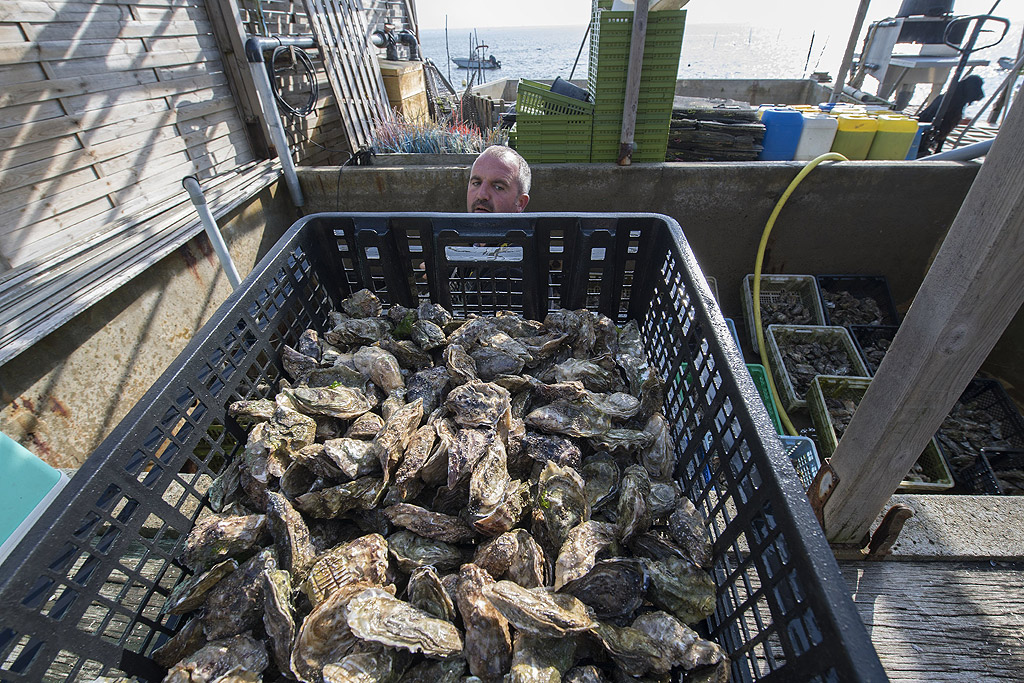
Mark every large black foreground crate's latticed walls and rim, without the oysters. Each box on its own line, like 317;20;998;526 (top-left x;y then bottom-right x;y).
0;213;886;681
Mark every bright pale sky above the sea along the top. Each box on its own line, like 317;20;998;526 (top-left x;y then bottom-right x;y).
416;0;1024;31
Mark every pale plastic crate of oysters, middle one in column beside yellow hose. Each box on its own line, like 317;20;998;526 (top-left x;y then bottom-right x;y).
765;325;867;411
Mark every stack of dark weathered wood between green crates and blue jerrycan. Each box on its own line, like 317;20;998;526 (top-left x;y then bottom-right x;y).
666;97;765;161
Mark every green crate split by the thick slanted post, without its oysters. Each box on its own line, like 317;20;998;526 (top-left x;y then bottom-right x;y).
807;375;953;494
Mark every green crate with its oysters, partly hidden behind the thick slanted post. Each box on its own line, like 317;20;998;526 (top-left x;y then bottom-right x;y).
807;375;953;494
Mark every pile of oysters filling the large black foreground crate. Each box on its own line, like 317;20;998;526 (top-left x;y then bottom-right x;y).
153;291;729;683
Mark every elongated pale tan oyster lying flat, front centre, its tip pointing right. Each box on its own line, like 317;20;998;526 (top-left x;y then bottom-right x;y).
483;581;595;638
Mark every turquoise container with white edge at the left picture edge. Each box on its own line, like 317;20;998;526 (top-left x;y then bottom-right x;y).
0;432;68;562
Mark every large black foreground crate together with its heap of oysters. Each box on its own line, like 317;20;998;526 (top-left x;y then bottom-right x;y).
0;214;885;681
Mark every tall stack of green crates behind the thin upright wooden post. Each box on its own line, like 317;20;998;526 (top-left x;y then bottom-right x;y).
587;0;686;162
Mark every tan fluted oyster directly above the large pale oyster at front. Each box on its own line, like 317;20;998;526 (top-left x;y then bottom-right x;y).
299;533;388;607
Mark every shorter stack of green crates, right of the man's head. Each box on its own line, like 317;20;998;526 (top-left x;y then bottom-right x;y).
515;79;594;163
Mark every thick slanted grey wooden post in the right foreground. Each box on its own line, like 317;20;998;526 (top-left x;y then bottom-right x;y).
824;88;1024;544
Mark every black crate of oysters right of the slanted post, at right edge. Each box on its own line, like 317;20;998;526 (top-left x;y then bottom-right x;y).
935;377;1024;494
